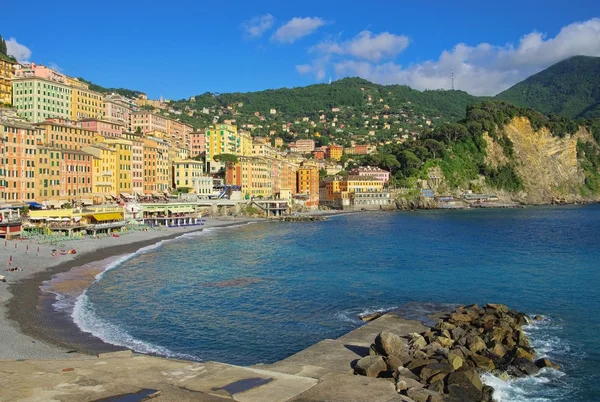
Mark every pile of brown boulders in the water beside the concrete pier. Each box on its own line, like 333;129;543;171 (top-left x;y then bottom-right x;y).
354;304;558;402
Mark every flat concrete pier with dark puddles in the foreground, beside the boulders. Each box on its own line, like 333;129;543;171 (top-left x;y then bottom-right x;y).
0;312;432;402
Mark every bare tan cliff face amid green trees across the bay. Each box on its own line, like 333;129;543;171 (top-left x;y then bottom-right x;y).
484;117;597;204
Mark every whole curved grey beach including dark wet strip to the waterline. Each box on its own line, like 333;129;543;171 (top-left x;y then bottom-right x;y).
0;218;268;360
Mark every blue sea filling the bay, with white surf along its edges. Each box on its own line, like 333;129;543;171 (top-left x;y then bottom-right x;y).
49;205;600;401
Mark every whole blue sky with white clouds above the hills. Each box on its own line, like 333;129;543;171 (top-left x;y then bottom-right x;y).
0;0;600;99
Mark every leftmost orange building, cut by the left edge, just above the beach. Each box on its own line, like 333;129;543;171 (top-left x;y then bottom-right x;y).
0;116;36;202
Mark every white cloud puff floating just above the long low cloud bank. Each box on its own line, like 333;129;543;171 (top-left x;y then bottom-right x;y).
310;31;409;62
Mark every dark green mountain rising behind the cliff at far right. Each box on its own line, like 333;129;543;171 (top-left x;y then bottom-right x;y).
496;56;600;119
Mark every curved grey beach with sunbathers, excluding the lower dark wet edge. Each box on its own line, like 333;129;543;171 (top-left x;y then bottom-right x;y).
0;218;257;360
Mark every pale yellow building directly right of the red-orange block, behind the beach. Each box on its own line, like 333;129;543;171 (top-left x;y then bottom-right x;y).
82;142;117;203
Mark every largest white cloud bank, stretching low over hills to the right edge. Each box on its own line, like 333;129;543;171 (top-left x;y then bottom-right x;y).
302;18;600;95
